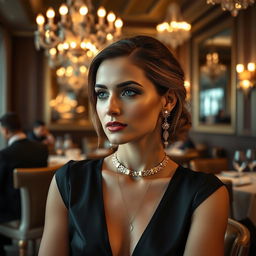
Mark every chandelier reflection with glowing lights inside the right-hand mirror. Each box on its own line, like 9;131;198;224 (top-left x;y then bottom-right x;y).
201;52;226;82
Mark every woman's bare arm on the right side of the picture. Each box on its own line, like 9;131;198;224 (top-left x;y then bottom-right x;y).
184;186;229;256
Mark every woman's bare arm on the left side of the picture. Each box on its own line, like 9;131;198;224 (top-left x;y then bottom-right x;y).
38;176;69;256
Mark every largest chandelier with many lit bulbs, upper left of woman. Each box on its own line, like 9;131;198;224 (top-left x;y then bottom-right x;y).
35;0;123;90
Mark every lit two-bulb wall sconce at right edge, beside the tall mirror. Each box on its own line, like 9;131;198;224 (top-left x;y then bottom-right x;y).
236;62;256;93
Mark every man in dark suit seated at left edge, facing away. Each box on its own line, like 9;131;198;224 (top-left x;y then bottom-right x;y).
0;113;48;251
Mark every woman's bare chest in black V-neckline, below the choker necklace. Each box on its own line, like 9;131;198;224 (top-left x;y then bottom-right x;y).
103;176;169;256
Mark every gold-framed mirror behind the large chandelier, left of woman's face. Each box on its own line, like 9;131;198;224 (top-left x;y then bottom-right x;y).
45;61;93;130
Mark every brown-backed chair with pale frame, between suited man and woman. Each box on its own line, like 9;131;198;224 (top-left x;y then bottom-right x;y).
0;165;62;256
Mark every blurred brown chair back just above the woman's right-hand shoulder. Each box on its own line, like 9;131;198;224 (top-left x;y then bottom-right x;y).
190;158;228;174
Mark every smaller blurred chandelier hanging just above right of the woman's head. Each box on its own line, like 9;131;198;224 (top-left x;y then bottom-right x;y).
156;3;191;49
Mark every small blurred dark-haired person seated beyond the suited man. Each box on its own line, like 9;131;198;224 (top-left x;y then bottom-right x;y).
28;120;55;146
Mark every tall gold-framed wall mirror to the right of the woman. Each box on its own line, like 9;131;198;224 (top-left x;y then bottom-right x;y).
192;19;236;133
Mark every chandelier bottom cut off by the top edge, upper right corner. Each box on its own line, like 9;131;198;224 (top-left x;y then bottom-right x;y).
207;0;255;16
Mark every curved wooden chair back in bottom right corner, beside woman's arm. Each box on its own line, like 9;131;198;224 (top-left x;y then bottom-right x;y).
224;219;250;256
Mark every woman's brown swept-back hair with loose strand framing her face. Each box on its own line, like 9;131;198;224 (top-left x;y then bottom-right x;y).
88;36;191;144
